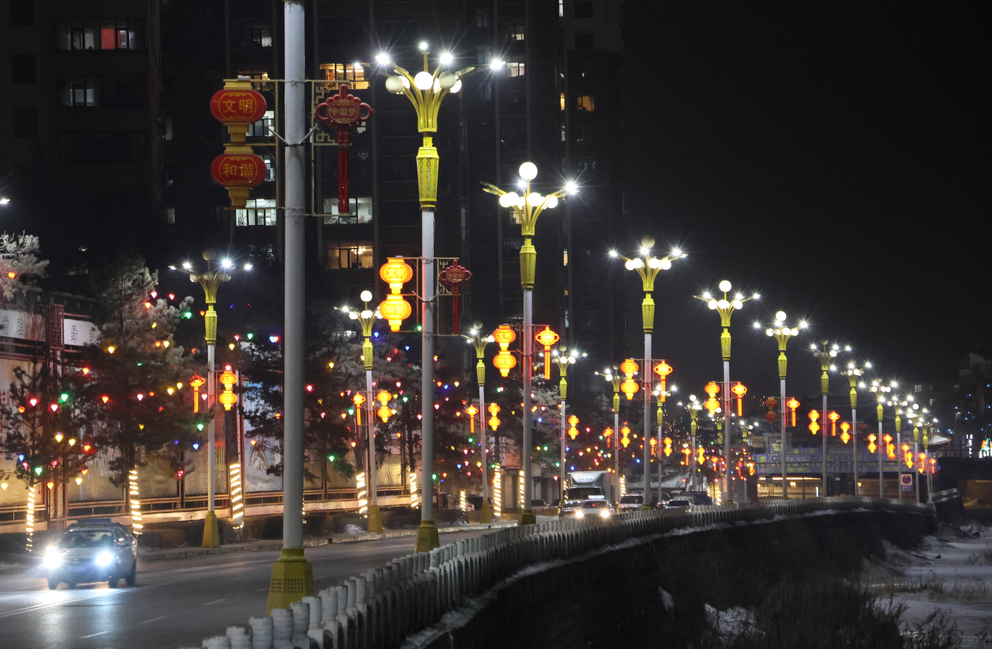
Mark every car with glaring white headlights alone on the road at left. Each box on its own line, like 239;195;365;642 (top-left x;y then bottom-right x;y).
43;519;138;590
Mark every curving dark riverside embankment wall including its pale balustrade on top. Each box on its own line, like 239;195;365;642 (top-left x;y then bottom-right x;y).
182;498;933;649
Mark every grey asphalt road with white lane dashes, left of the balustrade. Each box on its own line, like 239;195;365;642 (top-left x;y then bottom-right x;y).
0;531;485;649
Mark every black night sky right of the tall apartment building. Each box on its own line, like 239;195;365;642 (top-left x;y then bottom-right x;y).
624;2;992;394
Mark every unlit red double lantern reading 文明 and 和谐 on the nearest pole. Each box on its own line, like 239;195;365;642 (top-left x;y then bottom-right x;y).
210;81;268;208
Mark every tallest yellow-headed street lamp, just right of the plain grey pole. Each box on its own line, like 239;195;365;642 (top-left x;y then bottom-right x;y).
376;43;504;552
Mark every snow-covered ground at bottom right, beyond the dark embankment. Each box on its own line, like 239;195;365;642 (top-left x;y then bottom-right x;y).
862;524;992;648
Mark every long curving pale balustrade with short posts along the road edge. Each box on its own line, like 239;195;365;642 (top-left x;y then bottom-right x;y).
188;497;934;649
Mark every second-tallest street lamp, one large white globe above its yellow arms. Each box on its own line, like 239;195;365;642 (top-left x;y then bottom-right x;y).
483;162;575;525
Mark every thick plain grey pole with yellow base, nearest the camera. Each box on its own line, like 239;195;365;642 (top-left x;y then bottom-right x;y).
266;0;314;614
